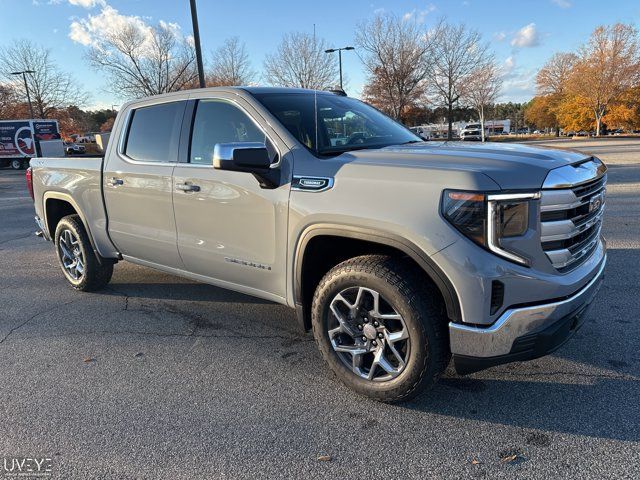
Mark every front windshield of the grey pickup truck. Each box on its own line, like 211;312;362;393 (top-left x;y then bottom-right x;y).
254;93;422;155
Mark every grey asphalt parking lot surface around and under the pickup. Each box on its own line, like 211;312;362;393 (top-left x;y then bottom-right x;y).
0;139;640;479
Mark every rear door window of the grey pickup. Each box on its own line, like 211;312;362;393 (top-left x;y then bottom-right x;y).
124;102;185;162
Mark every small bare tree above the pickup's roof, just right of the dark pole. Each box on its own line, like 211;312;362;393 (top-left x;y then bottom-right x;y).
207;37;256;87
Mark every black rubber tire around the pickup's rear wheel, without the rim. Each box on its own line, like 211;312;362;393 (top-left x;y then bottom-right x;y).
54;215;114;292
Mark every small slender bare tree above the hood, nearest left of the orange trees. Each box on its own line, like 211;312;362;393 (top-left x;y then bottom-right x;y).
460;57;502;142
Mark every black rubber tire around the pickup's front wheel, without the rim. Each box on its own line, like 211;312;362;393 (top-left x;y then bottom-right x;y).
312;255;451;403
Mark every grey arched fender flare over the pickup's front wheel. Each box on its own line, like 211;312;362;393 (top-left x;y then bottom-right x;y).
293;223;462;326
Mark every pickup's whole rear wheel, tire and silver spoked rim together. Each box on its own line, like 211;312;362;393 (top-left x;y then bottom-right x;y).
55;215;113;292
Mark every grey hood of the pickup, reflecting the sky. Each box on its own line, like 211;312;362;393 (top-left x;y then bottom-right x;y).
344;142;588;189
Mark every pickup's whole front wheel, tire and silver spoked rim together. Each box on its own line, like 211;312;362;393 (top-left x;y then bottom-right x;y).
312;255;450;402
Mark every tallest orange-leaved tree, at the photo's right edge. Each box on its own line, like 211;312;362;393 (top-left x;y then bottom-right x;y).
567;23;640;135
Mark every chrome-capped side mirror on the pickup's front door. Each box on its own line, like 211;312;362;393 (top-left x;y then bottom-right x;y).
213;142;280;188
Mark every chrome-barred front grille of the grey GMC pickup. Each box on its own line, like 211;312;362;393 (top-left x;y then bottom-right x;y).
540;163;607;272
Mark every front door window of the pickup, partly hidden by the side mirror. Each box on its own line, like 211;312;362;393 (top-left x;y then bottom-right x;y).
189;100;266;165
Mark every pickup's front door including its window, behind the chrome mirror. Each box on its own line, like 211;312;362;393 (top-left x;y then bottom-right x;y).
173;98;289;298
